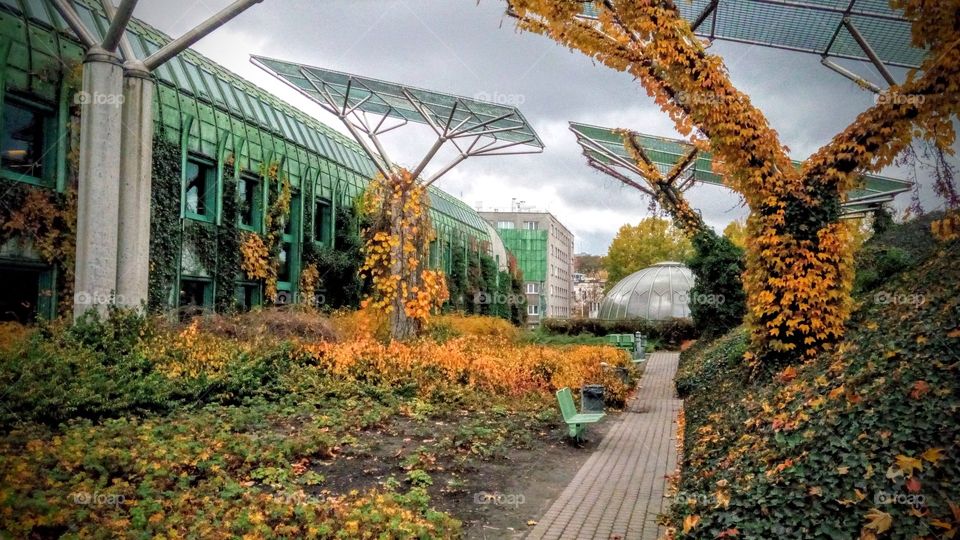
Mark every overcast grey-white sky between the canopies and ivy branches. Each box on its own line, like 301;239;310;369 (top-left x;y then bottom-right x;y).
135;0;956;254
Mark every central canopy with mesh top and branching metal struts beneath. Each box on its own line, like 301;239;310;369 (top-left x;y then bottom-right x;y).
251;56;543;185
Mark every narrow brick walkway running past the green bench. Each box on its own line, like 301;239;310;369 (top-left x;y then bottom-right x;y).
527;353;682;540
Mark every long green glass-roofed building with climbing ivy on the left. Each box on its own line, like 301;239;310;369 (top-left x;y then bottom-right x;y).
0;0;499;321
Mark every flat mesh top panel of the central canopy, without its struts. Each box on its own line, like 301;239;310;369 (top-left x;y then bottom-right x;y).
253;56;543;148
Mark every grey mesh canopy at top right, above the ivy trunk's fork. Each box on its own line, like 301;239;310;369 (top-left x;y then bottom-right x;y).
583;0;927;92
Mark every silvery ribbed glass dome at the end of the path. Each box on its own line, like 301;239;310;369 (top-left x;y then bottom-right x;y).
600;261;694;321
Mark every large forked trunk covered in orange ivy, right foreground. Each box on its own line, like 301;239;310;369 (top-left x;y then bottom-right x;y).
508;0;960;364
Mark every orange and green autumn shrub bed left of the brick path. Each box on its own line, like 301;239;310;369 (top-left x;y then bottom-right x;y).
0;312;630;538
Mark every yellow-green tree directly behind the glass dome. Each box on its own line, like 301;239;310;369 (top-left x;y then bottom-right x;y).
604;217;693;286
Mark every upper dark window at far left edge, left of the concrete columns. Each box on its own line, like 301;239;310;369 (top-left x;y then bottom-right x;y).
0;95;56;180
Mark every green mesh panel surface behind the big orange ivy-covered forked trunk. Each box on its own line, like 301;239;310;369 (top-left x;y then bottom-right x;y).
570;122;912;212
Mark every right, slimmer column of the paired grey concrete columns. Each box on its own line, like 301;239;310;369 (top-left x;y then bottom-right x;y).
116;62;154;308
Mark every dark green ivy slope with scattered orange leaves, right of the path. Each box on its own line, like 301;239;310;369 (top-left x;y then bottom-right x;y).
667;229;960;539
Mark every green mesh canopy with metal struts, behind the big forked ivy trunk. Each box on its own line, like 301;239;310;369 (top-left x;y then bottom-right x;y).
570;122;912;218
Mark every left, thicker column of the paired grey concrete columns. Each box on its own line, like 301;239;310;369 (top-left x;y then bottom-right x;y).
73;47;123;316
